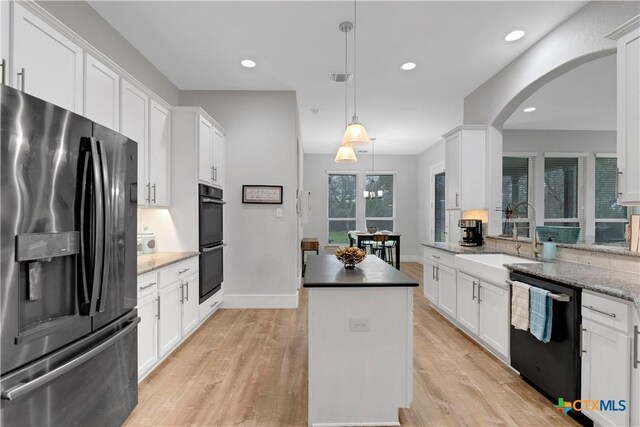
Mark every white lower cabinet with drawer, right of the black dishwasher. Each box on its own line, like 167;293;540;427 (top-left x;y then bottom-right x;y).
580;292;640;426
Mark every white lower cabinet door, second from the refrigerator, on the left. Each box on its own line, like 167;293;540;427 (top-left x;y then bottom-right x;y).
158;281;182;357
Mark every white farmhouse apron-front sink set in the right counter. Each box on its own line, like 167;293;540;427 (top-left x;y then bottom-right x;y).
455;254;539;287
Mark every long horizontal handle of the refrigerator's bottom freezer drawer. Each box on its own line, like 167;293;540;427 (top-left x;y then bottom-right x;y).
0;317;140;400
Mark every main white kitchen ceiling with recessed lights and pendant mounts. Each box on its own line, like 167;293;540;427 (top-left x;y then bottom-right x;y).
89;1;586;154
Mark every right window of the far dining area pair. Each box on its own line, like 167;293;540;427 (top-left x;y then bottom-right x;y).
364;175;394;231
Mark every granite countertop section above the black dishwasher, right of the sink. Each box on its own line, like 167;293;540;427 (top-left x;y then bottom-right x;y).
505;260;640;312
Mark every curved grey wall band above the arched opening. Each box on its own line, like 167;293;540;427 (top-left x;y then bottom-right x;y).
464;1;640;125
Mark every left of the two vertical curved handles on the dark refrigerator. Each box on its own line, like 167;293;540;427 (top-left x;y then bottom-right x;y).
87;137;104;316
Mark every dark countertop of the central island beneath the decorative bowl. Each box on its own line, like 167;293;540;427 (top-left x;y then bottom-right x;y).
304;255;418;288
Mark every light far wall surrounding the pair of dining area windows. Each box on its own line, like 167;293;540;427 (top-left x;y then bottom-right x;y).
303;154;421;262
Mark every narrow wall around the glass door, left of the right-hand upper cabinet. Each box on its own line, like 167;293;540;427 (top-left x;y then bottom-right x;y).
416;140;445;247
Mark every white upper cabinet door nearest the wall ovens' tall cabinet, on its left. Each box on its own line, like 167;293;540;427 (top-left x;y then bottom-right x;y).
147;100;171;207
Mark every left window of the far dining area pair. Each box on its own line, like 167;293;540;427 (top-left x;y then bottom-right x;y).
327;174;357;244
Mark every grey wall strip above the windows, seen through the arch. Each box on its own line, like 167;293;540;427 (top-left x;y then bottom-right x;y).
502;129;616;153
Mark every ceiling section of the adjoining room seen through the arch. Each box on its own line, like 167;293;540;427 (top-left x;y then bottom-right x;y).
504;55;616;131
